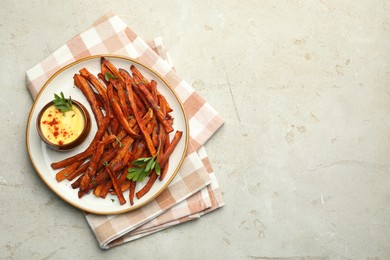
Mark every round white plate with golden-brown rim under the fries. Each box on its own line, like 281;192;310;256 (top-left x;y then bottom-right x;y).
26;55;188;214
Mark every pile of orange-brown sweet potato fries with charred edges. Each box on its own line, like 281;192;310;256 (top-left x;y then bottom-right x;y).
51;57;183;205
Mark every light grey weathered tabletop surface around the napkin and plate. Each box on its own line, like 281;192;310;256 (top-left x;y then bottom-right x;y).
0;0;390;259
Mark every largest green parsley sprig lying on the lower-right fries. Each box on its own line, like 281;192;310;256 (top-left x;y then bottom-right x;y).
127;140;161;182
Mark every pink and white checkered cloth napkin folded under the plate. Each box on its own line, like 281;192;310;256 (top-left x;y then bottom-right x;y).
27;14;224;249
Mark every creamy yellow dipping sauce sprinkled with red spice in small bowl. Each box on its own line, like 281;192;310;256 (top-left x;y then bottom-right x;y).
40;105;85;145
